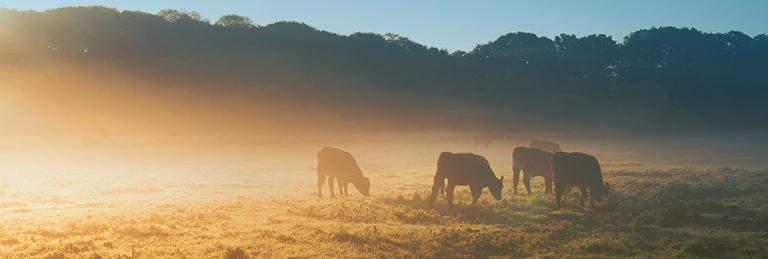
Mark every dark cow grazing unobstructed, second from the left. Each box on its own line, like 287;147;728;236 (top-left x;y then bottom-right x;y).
429;152;504;212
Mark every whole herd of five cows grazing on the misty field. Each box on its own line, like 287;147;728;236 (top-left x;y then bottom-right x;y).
317;140;610;212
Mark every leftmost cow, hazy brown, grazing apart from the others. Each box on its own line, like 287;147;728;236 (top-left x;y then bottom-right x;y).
317;147;371;198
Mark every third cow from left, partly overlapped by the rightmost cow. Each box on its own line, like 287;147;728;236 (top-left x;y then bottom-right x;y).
512;146;552;195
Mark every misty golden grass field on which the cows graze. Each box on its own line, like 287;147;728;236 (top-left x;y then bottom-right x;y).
0;132;768;258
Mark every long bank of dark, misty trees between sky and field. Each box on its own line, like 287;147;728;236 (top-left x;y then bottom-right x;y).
0;6;768;133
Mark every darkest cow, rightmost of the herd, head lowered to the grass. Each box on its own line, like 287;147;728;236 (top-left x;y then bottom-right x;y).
551;152;610;209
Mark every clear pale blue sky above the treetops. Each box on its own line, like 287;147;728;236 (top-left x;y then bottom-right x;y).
0;0;768;51
